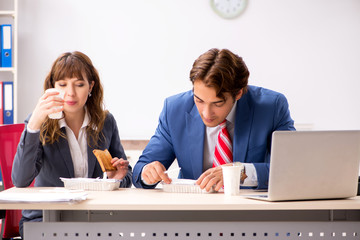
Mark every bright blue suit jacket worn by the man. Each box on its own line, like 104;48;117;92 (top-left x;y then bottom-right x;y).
133;86;295;189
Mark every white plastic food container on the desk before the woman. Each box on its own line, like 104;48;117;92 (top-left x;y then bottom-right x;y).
60;178;121;191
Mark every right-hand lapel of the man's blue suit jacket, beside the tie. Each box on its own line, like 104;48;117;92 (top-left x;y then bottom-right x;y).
233;94;254;162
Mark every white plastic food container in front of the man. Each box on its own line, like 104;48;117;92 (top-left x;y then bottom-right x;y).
161;179;216;193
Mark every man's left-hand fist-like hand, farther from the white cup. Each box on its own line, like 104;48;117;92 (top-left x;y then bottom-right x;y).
141;161;171;185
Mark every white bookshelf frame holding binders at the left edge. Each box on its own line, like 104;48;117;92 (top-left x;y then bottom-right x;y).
0;0;18;123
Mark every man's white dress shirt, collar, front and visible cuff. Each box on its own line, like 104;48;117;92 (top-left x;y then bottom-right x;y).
203;102;258;187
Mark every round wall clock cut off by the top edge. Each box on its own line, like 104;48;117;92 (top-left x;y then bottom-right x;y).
210;0;247;19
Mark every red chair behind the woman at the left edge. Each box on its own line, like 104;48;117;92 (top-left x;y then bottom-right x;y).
0;123;25;239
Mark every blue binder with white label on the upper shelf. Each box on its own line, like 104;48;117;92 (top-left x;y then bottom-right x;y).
0;24;12;67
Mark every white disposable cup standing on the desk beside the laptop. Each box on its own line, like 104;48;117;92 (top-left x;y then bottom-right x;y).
221;165;241;196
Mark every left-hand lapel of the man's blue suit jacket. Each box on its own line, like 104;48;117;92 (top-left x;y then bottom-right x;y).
185;105;205;179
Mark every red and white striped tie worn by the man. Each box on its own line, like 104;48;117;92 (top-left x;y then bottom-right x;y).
213;119;233;167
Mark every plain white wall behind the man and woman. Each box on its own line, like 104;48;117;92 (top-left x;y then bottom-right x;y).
18;0;360;139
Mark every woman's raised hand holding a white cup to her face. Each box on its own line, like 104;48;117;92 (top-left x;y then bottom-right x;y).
28;92;64;130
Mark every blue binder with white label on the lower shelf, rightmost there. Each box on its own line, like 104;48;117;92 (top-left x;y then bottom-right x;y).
3;82;14;124
